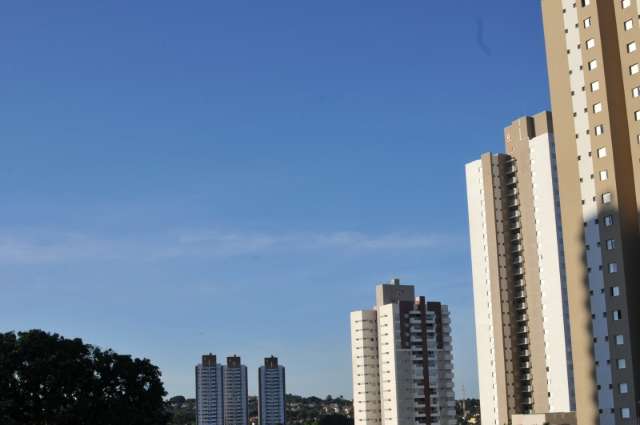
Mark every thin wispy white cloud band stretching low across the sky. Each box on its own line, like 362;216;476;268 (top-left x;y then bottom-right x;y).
0;229;452;264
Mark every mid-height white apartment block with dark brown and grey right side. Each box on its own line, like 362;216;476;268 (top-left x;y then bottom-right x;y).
351;279;456;425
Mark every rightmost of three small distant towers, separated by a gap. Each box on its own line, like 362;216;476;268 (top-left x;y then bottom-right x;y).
258;356;286;425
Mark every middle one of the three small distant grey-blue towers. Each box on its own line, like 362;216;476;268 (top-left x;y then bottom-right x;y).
222;356;249;425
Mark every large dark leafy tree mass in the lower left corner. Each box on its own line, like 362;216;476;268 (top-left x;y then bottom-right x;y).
0;330;168;425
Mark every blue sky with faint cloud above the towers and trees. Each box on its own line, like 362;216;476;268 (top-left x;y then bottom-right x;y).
0;0;548;396
